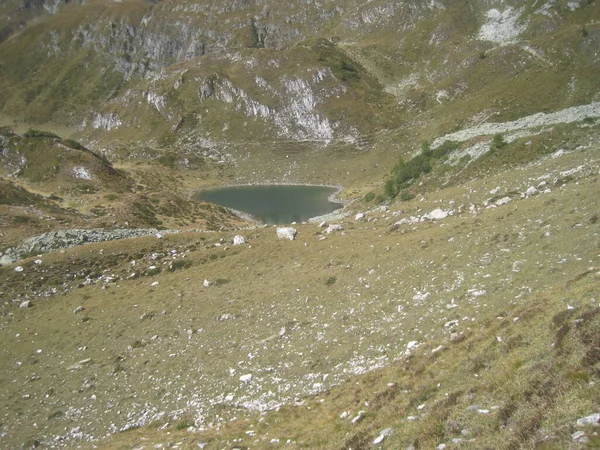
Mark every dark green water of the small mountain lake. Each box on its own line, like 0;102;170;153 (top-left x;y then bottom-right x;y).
194;185;343;225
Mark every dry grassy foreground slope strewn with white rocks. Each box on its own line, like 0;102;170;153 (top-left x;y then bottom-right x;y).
0;138;600;448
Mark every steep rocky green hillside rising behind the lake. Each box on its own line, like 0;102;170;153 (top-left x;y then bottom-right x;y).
0;0;600;183
